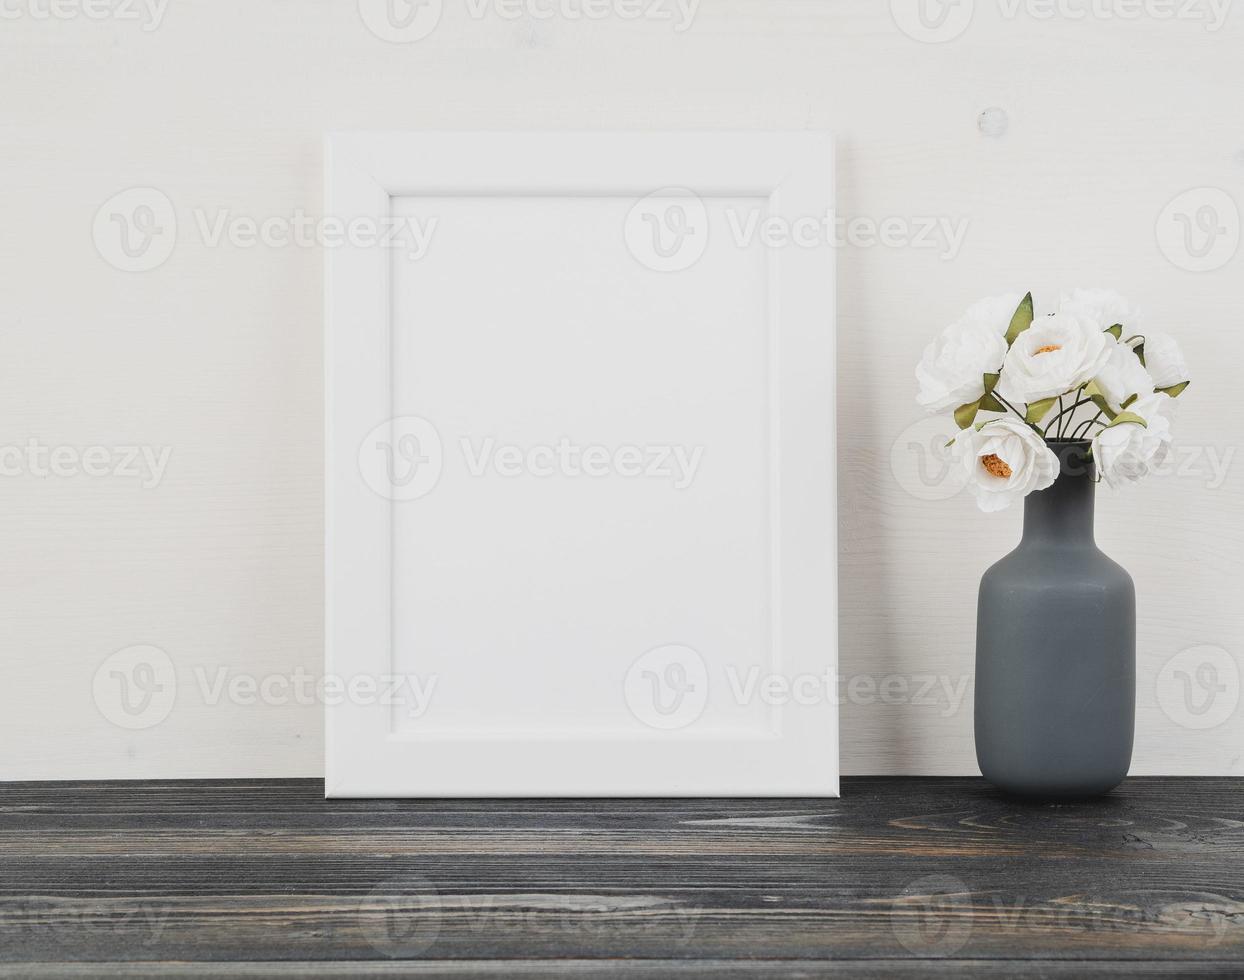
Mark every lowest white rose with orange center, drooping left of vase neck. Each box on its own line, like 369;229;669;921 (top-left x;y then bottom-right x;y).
954;417;1059;511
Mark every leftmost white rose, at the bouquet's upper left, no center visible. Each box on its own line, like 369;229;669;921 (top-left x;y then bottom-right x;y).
916;295;1023;413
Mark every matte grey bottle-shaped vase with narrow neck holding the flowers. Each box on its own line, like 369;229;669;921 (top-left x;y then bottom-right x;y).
975;441;1136;797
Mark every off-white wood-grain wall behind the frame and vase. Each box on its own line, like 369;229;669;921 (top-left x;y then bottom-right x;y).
0;0;1244;779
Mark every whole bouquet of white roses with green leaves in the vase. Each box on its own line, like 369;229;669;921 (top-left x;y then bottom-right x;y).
916;290;1188;511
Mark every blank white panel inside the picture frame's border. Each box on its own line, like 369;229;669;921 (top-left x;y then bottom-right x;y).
392;194;774;737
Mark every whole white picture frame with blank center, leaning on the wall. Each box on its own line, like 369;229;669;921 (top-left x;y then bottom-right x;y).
325;132;838;797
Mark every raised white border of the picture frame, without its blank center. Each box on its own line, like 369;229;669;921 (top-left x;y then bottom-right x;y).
325;132;838;797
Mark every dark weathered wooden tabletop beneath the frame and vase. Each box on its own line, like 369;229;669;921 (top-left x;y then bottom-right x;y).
0;779;1244;978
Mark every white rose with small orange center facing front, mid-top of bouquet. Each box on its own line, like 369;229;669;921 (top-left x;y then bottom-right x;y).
998;311;1115;403
